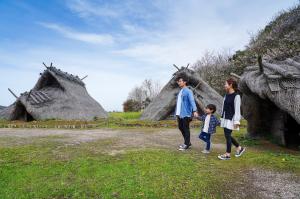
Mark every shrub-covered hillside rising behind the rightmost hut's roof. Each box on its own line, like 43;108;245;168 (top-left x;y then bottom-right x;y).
232;4;300;67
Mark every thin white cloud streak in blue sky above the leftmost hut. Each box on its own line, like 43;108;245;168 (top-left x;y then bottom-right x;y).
39;22;114;44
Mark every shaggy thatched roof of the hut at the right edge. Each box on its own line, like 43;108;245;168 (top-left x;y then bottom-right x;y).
240;56;300;124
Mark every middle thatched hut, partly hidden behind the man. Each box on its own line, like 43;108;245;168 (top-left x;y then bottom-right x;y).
141;67;222;120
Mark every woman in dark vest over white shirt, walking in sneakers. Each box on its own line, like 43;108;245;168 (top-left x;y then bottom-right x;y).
218;79;245;160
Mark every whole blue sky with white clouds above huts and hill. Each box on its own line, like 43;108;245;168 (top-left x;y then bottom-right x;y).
0;0;299;111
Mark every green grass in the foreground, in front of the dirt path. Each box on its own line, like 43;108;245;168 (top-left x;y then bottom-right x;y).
0;113;300;199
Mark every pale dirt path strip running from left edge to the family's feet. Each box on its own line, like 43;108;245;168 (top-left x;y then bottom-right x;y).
0;129;224;150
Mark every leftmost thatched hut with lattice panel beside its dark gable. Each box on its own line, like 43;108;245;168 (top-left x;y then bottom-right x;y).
0;65;107;121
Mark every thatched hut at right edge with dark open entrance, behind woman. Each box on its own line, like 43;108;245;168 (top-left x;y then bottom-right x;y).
240;56;300;147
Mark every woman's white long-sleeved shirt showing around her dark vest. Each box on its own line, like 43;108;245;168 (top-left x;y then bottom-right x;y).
220;95;241;130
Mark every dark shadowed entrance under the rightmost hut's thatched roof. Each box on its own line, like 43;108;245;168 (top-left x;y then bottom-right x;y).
243;93;300;149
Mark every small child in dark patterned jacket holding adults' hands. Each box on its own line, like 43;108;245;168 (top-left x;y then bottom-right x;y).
199;104;220;153
